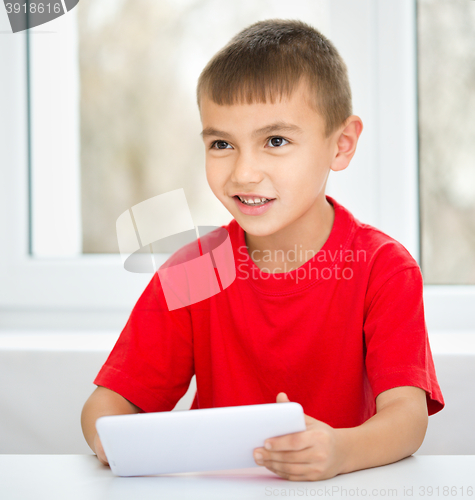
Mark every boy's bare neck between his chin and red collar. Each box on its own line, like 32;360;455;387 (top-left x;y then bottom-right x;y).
244;195;335;273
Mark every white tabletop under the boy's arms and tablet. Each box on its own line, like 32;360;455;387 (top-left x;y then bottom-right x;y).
0;455;475;500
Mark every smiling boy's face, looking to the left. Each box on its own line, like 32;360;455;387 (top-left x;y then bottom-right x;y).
201;83;341;240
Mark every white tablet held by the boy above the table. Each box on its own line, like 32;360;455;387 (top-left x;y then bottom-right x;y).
96;402;306;476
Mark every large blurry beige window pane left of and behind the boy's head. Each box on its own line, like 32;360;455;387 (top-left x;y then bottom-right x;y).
77;0;328;253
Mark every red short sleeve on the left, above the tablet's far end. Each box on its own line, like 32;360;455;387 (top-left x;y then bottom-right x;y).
94;273;194;412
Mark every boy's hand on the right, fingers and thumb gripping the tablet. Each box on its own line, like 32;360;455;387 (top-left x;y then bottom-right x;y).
254;392;344;481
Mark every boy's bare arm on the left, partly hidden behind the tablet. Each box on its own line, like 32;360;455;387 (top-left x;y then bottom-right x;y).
81;386;141;465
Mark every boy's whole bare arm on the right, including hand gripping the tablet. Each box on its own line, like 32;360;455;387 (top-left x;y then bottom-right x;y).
254;386;429;481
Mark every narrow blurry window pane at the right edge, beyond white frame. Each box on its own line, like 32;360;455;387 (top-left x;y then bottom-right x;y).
417;0;475;284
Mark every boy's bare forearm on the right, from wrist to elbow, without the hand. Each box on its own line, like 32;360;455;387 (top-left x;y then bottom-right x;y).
336;399;428;473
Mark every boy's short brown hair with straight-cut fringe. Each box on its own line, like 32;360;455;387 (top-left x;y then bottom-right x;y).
196;19;352;138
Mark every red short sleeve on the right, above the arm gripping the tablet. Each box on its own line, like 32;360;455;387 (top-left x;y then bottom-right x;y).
364;266;445;415
